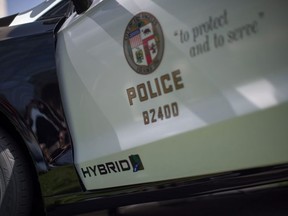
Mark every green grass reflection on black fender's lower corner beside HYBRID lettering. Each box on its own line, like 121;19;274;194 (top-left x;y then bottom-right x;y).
39;165;82;197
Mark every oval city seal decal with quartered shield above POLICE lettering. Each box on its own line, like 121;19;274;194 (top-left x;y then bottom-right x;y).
124;12;164;74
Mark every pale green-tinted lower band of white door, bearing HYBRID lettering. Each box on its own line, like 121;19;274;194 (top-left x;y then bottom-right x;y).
78;104;288;190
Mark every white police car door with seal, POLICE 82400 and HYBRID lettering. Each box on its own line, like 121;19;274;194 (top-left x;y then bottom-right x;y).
57;0;288;190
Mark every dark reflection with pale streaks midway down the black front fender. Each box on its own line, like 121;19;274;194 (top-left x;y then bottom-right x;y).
26;84;71;164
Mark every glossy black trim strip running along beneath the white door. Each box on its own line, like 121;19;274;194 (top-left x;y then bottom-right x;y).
45;164;288;216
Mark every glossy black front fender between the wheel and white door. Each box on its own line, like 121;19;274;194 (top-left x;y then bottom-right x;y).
0;0;82;209
